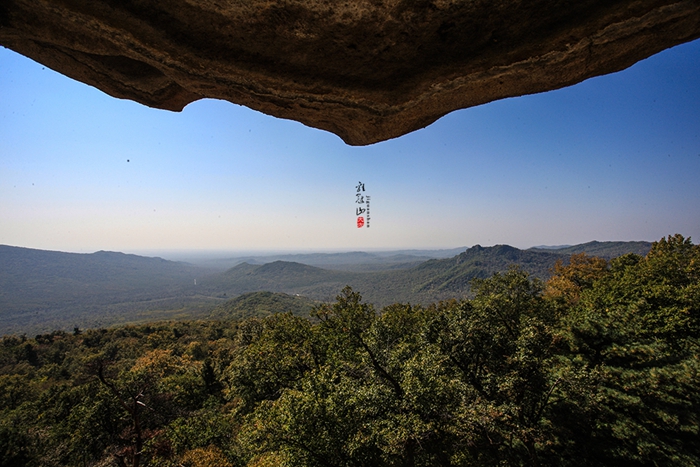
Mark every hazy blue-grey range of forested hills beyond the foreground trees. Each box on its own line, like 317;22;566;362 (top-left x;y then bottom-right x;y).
0;242;651;334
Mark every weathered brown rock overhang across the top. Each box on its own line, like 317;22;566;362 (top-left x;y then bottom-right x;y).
0;0;700;145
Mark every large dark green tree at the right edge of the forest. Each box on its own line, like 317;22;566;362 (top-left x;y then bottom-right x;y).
562;235;700;466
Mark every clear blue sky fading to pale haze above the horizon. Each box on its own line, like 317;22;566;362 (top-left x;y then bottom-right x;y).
0;40;700;252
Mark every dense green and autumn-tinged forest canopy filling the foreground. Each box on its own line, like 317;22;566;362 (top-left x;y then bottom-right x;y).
0;235;700;467
